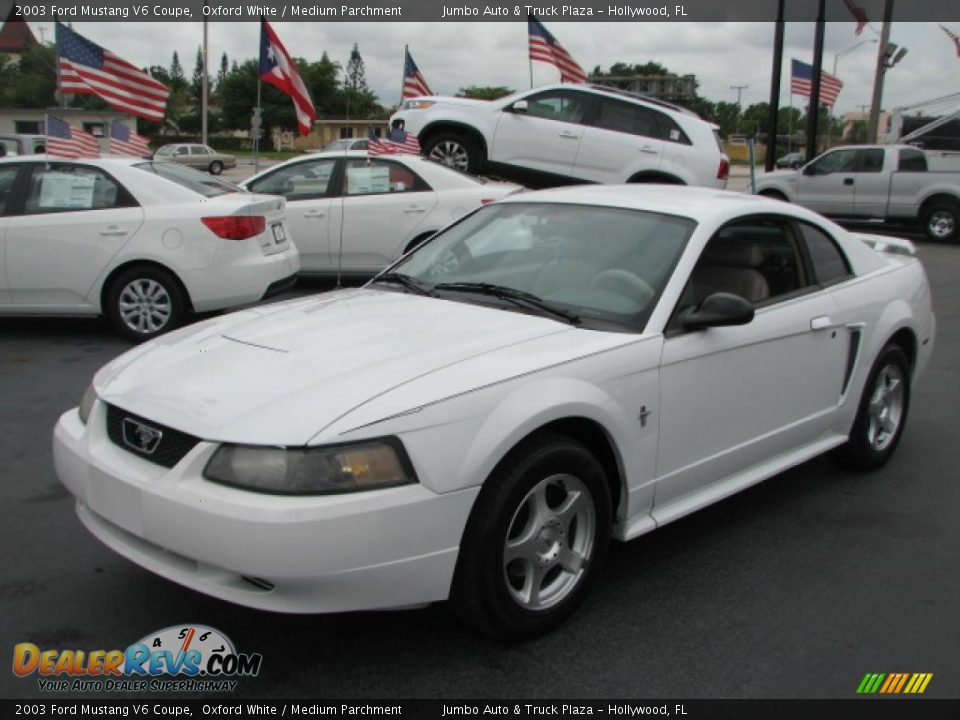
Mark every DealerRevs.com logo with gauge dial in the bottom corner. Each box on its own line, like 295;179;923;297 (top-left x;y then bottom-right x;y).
13;625;263;692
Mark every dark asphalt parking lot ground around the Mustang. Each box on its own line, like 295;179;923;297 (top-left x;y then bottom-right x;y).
0;224;960;699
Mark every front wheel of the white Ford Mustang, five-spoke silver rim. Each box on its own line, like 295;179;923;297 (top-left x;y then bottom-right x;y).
450;435;612;640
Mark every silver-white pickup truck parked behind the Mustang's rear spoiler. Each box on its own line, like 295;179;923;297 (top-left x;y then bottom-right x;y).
753;145;960;241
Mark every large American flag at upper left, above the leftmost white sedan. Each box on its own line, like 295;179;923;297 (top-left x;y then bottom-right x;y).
56;23;170;121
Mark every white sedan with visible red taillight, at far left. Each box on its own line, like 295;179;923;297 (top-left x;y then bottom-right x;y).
0;155;300;341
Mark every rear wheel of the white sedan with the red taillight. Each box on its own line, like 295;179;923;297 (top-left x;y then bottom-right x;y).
104;266;186;342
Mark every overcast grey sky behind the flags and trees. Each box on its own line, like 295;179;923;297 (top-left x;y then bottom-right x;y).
22;22;960;112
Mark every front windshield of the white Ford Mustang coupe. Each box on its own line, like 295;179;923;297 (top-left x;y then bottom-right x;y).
391;203;695;331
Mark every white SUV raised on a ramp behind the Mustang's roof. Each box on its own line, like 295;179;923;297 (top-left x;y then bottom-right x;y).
390;85;730;188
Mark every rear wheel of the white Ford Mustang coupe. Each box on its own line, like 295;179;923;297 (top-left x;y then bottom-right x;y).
834;344;910;470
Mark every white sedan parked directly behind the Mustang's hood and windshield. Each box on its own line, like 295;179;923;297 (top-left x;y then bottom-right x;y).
241;151;522;276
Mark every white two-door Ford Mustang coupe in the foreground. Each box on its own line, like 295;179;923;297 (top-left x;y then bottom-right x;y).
54;186;935;638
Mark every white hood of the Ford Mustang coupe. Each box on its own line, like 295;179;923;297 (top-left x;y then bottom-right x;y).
94;289;571;445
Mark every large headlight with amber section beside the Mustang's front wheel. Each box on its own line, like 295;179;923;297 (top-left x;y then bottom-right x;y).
203;437;417;495
